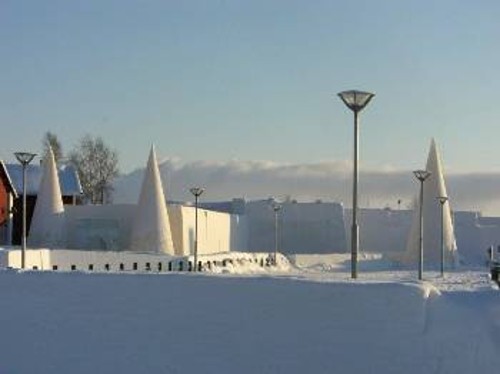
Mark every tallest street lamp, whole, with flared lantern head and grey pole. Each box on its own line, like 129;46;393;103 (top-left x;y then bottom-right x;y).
338;90;375;278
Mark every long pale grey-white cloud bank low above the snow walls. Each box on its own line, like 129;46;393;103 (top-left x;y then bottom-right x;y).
115;159;500;215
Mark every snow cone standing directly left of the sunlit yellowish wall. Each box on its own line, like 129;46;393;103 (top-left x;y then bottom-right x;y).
129;146;174;255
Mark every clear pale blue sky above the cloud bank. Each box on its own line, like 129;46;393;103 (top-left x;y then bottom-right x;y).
0;0;500;173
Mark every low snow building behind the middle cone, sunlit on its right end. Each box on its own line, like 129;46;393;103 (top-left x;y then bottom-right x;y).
62;204;245;256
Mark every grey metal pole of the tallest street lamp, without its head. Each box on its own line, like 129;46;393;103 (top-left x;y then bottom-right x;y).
351;111;359;278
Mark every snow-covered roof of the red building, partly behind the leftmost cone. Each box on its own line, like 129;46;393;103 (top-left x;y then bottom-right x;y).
5;164;82;196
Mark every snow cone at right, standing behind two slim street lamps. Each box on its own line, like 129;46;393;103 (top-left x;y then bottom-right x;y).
404;139;457;268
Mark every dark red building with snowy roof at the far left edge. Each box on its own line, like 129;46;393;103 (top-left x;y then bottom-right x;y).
0;160;82;245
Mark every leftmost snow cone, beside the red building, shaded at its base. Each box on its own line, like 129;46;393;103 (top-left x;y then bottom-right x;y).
28;147;65;248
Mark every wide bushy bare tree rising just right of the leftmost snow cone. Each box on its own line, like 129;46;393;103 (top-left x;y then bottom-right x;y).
69;135;119;204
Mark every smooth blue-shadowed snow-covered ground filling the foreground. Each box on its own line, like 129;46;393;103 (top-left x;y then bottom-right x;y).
0;255;500;374
